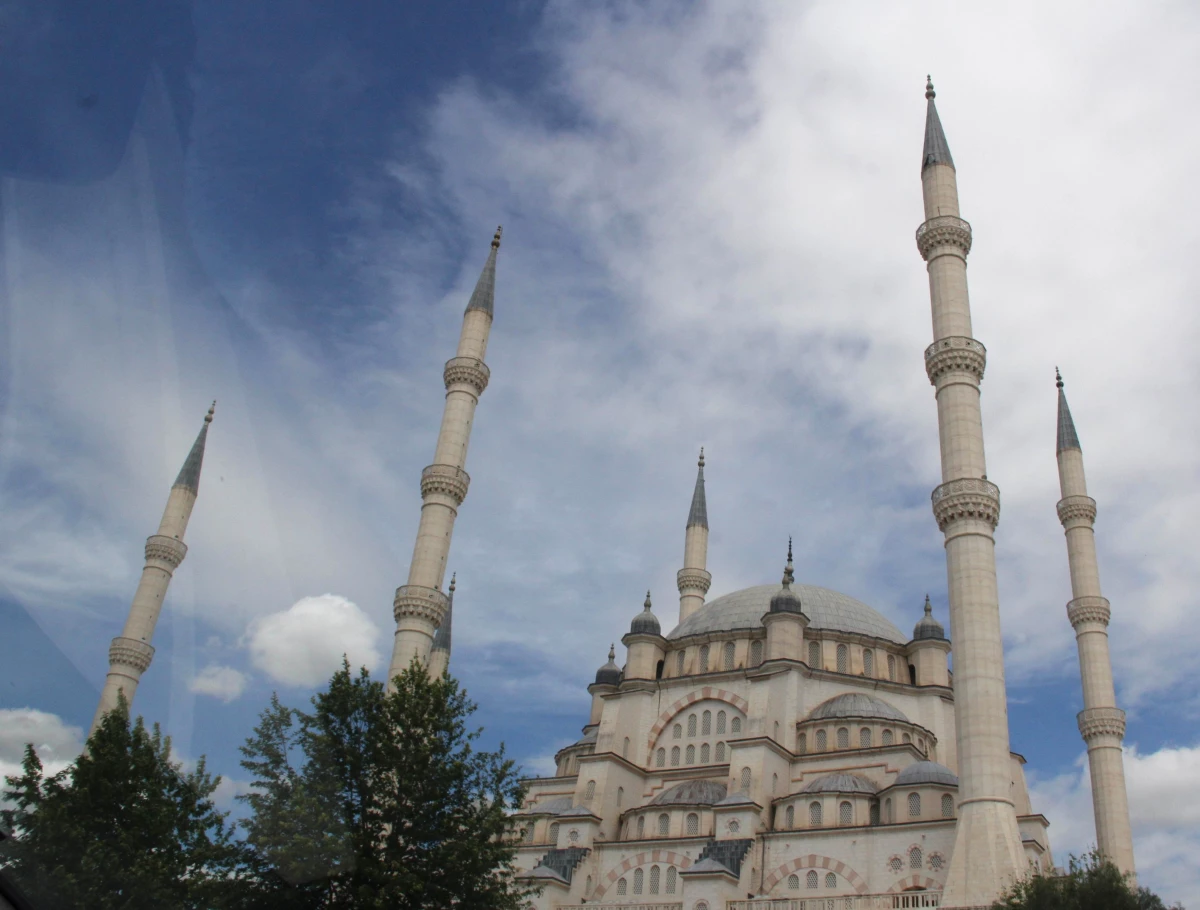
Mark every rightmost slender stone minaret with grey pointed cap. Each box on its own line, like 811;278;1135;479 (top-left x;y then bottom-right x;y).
1055;369;1134;878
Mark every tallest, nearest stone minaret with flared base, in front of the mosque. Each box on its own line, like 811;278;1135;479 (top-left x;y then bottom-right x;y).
917;82;1027;906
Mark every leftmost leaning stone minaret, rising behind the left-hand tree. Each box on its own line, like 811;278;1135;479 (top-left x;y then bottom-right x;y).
88;401;217;736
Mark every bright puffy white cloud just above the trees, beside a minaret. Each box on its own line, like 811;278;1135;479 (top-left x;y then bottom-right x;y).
246;594;380;686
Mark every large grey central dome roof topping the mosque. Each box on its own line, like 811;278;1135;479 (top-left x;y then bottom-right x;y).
667;585;908;645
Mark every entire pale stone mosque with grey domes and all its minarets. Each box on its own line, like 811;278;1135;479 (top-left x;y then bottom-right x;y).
96;84;1134;910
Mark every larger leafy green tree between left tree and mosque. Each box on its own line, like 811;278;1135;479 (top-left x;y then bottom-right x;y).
241;661;527;910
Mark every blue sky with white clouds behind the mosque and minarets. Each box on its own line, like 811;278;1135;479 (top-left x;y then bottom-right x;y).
0;0;1200;905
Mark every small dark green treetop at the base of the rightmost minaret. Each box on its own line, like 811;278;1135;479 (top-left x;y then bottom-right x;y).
992;852;1183;910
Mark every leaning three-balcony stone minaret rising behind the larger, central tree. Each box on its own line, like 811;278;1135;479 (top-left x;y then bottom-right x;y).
388;228;500;684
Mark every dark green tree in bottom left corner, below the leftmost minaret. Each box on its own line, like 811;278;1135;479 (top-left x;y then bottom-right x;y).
0;700;242;910
